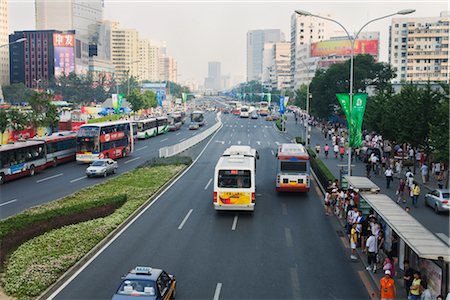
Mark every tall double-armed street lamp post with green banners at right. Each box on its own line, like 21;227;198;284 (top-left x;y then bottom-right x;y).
295;9;416;175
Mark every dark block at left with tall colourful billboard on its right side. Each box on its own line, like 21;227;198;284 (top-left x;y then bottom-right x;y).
9;30;76;88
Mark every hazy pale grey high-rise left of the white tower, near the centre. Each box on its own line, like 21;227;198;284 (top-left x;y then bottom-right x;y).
247;29;284;81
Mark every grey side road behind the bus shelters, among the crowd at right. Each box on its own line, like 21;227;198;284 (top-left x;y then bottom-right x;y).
300;120;450;237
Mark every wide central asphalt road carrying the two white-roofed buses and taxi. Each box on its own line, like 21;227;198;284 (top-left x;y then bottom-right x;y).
53;115;369;299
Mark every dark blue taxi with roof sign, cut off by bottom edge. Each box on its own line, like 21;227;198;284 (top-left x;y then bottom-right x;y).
112;267;177;300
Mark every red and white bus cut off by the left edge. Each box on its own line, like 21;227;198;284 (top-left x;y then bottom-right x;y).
0;141;47;184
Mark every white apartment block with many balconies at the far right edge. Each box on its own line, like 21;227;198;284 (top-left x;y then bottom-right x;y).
389;12;450;83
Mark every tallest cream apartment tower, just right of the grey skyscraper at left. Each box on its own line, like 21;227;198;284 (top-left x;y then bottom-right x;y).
111;22;140;81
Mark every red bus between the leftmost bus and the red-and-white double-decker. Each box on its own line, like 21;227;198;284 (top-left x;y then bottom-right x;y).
31;131;77;168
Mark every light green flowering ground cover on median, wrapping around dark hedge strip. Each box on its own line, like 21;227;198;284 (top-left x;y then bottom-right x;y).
2;165;184;299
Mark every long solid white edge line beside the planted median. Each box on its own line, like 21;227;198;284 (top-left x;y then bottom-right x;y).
48;116;221;300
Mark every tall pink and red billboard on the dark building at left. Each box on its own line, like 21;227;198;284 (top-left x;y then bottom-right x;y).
53;33;75;77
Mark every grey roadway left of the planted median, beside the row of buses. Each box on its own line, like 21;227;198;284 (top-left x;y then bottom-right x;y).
0;113;216;219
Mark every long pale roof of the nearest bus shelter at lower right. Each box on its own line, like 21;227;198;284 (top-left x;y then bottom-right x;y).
360;193;450;262
